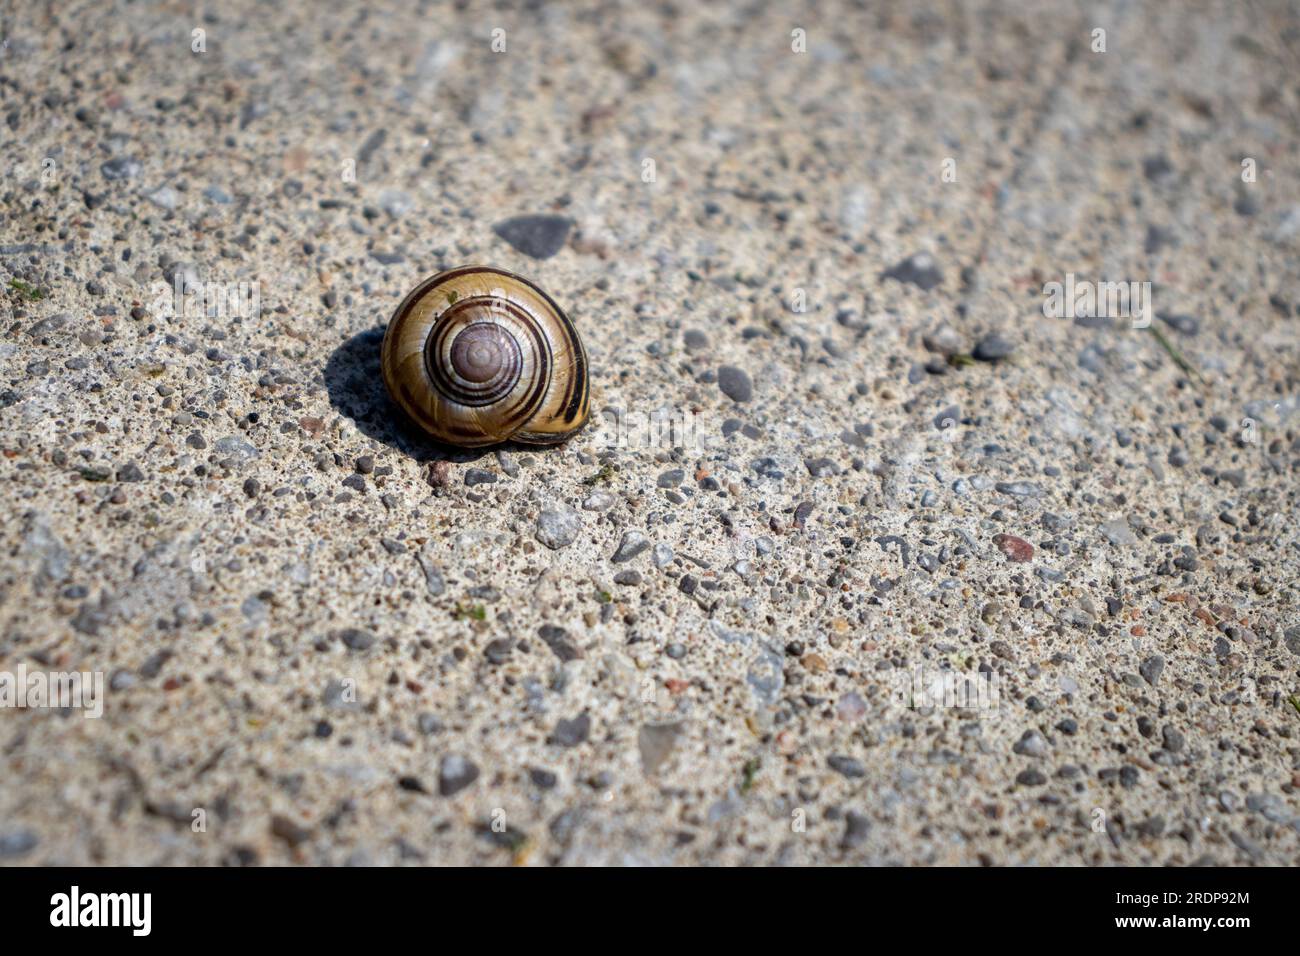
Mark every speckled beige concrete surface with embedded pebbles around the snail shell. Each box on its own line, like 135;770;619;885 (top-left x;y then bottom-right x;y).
0;0;1300;865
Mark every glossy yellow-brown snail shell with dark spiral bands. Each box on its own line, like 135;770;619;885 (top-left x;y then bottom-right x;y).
380;265;588;447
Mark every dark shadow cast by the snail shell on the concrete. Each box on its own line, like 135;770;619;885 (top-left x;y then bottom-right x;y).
325;325;488;462
